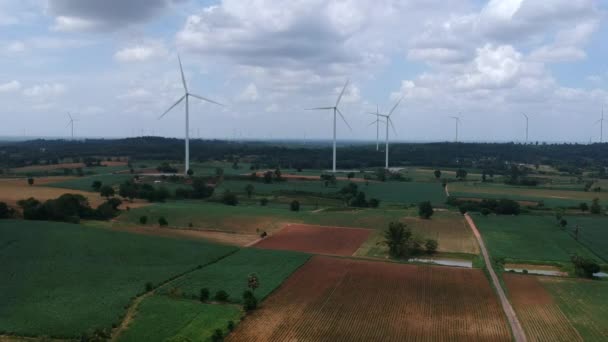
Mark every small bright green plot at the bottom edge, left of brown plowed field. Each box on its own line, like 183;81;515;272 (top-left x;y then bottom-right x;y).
118;295;242;342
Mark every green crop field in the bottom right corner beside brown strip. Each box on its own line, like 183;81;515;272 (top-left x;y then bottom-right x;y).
541;278;608;341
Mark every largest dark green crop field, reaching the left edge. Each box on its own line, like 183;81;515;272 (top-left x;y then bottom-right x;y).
0;220;236;337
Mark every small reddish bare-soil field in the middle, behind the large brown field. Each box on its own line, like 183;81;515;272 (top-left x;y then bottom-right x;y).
255;224;372;256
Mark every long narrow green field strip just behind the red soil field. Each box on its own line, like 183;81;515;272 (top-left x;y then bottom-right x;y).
118;201;407;233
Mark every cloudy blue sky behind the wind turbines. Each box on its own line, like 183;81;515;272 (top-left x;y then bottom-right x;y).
0;0;608;143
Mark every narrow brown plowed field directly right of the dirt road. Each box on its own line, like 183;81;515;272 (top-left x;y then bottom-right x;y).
504;273;583;341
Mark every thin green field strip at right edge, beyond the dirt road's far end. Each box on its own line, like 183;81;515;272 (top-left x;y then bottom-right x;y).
449;182;608;207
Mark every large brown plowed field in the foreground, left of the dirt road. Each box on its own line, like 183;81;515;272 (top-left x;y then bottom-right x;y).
227;256;511;341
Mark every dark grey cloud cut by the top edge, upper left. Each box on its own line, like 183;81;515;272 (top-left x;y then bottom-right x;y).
48;0;181;31
